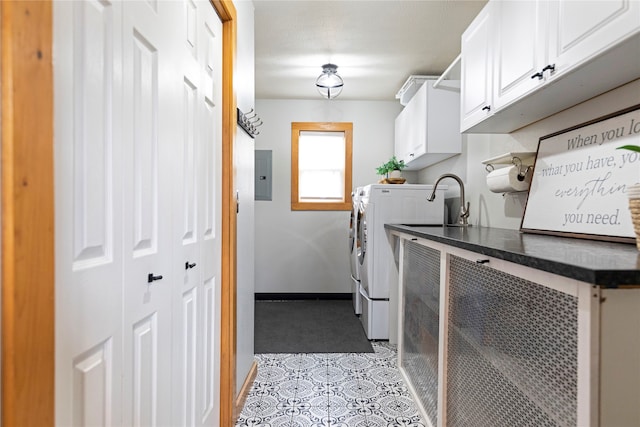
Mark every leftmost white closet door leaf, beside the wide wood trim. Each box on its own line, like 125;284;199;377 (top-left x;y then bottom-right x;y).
53;1;122;426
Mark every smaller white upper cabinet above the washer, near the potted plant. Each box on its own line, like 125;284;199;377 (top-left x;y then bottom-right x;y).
395;80;462;170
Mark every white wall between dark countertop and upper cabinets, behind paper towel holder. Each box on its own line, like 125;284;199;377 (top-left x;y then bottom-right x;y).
416;80;640;230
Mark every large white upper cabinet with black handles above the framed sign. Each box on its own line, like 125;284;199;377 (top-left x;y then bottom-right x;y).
461;0;640;133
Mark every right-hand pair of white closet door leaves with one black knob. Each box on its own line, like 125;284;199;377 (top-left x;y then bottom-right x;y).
173;0;222;426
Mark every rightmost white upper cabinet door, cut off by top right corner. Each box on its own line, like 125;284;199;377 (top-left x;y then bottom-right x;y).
549;0;640;77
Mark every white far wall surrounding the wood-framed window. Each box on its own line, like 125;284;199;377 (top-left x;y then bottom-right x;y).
255;100;402;293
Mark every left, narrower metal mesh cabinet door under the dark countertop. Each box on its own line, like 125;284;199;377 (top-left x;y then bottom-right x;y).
400;240;440;425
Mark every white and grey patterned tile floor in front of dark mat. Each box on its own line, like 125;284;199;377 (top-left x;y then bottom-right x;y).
236;343;427;427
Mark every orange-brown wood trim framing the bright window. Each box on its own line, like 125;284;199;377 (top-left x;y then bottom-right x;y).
291;122;353;211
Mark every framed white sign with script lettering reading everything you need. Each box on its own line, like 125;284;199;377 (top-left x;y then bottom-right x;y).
521;105;640;242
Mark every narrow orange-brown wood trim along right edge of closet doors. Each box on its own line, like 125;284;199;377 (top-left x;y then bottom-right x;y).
211;0;237;427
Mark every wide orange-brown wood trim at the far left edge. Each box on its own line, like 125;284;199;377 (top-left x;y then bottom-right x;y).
0;1;55;426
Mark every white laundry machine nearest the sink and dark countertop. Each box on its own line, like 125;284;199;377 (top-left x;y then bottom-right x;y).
356;184;447;339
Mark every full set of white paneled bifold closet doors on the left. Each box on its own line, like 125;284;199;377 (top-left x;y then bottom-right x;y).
54;0;222;426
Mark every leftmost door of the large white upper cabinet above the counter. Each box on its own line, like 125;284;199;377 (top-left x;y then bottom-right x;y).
460;2;494;131
